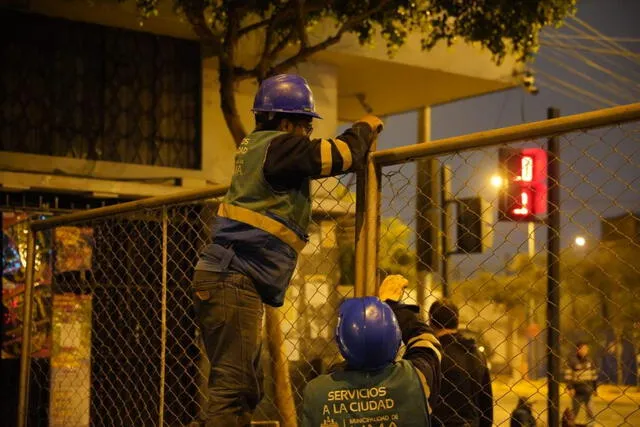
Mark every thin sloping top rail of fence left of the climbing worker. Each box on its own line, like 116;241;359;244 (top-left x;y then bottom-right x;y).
31;185;229;231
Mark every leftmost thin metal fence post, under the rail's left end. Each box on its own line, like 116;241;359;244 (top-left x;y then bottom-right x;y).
17;227;36;427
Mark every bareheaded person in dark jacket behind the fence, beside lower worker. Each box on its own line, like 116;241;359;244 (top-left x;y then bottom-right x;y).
429;300;493;427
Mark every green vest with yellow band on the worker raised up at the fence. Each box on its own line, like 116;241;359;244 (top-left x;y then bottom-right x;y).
218;131;311;252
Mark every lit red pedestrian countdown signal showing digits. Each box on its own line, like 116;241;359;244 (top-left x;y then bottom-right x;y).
498;148;547;222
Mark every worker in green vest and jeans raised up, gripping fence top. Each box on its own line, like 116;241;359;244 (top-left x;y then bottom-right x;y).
193;74;382;426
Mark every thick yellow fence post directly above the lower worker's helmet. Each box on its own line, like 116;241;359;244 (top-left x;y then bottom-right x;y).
365;158;381;295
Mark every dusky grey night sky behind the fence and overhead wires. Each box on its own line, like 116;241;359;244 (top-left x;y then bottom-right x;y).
340;0;640;277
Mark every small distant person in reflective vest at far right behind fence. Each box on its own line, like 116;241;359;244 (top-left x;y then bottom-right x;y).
564;342;598;423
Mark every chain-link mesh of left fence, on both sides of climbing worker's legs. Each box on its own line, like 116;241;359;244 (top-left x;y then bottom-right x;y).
6;175;355;426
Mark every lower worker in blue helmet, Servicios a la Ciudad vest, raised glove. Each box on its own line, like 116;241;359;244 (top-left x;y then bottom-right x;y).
302;275;441;427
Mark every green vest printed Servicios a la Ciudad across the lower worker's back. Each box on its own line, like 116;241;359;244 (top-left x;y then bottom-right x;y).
303;360;430;427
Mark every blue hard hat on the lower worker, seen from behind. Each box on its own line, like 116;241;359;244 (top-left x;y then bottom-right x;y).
336;297;402;371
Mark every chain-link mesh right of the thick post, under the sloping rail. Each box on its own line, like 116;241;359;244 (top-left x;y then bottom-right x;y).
378;123;640;426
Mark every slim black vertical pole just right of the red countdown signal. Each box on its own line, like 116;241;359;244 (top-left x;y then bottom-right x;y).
546;108;560;427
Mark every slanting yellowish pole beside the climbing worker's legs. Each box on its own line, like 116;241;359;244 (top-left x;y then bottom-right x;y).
265;306;298;427
